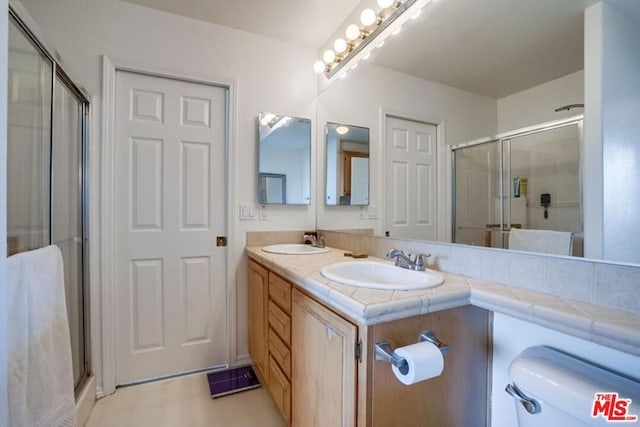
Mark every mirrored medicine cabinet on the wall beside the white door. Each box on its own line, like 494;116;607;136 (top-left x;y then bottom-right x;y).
258;113;311;205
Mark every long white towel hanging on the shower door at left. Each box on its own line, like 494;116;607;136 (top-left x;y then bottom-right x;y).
7;246;76;427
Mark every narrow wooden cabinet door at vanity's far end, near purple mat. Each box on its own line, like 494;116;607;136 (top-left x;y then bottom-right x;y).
247;260;269;381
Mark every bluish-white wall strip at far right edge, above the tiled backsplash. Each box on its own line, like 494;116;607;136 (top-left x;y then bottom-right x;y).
601;1;640;263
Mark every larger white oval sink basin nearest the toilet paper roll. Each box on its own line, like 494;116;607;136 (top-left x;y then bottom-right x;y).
320;261;444;291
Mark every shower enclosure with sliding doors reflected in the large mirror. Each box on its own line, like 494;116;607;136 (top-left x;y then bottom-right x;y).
451;118;583;256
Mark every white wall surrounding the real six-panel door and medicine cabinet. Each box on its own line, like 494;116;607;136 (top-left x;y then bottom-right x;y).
18;0;316;394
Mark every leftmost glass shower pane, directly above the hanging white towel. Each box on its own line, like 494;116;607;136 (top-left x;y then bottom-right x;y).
7;14;53;255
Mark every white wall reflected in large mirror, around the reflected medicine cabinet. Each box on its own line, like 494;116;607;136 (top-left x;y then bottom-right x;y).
316;63;496;234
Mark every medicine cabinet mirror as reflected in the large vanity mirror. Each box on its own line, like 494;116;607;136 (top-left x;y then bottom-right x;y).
325;123;369;206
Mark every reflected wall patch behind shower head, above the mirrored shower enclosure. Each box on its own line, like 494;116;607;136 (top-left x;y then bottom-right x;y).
498;71;584;133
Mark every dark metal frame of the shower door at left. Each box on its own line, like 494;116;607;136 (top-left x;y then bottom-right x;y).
7;4;93;400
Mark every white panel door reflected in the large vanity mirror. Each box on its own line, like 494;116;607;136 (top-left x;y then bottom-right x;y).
385;117;437;240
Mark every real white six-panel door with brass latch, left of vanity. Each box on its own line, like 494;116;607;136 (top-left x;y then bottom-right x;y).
115;71;228;384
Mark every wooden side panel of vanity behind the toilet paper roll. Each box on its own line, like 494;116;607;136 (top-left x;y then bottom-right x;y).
368;305;491;427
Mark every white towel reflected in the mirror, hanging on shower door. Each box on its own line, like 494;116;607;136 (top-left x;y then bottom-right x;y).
509;228;573;255
